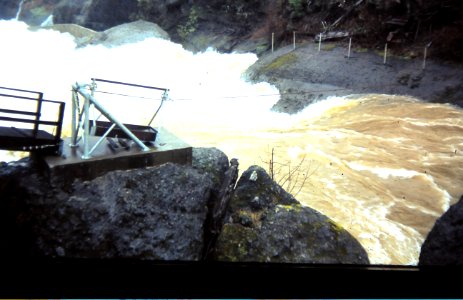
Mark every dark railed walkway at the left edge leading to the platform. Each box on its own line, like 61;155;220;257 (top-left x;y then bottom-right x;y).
0;87;65;155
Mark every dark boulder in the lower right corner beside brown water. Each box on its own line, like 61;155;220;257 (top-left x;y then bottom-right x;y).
419;197;463;266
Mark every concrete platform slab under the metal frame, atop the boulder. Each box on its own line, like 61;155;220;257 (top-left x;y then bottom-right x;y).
43;128;192;183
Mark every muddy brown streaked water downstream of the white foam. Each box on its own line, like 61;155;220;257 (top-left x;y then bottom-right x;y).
169;94;463;265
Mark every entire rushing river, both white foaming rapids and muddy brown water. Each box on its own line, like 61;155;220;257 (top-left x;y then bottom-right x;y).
0;21;463;264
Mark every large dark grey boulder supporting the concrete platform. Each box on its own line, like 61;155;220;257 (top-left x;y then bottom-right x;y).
0;148;232;260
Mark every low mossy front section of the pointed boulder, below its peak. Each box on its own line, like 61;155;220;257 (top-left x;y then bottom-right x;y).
214;205;369;264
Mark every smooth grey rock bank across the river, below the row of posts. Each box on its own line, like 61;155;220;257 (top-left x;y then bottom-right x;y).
246;41;463;113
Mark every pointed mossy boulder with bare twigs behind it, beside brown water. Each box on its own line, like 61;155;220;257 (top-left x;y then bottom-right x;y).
214;166;369;264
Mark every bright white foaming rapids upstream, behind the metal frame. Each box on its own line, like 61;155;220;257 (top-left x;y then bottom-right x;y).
0;21;279;151
